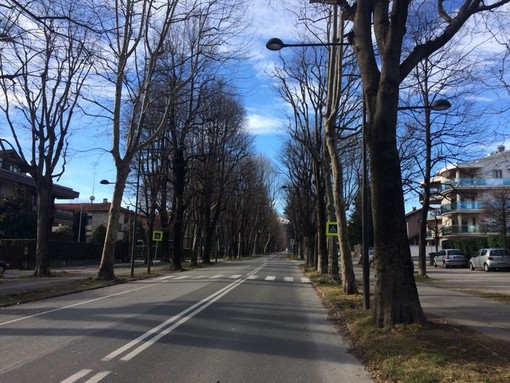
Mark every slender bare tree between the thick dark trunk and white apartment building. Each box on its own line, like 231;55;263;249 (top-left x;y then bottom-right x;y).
399;30;492;276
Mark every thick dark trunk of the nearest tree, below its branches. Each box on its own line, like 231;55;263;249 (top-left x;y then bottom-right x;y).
367;95;426;327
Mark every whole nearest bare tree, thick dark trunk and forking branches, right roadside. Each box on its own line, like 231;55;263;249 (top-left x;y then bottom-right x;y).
330;0;508;327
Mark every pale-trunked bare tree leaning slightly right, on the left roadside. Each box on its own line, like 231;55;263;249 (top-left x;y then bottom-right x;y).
92;0;198;280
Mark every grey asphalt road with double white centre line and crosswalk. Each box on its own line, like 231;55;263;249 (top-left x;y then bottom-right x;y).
0;256;371;383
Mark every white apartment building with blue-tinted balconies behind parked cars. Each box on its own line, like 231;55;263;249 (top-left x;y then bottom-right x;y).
427;145;510;244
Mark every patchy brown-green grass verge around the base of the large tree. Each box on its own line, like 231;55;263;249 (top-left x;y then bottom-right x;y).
305;271;510;383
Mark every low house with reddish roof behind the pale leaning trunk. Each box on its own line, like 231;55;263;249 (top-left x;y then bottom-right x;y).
55;198;135;242
